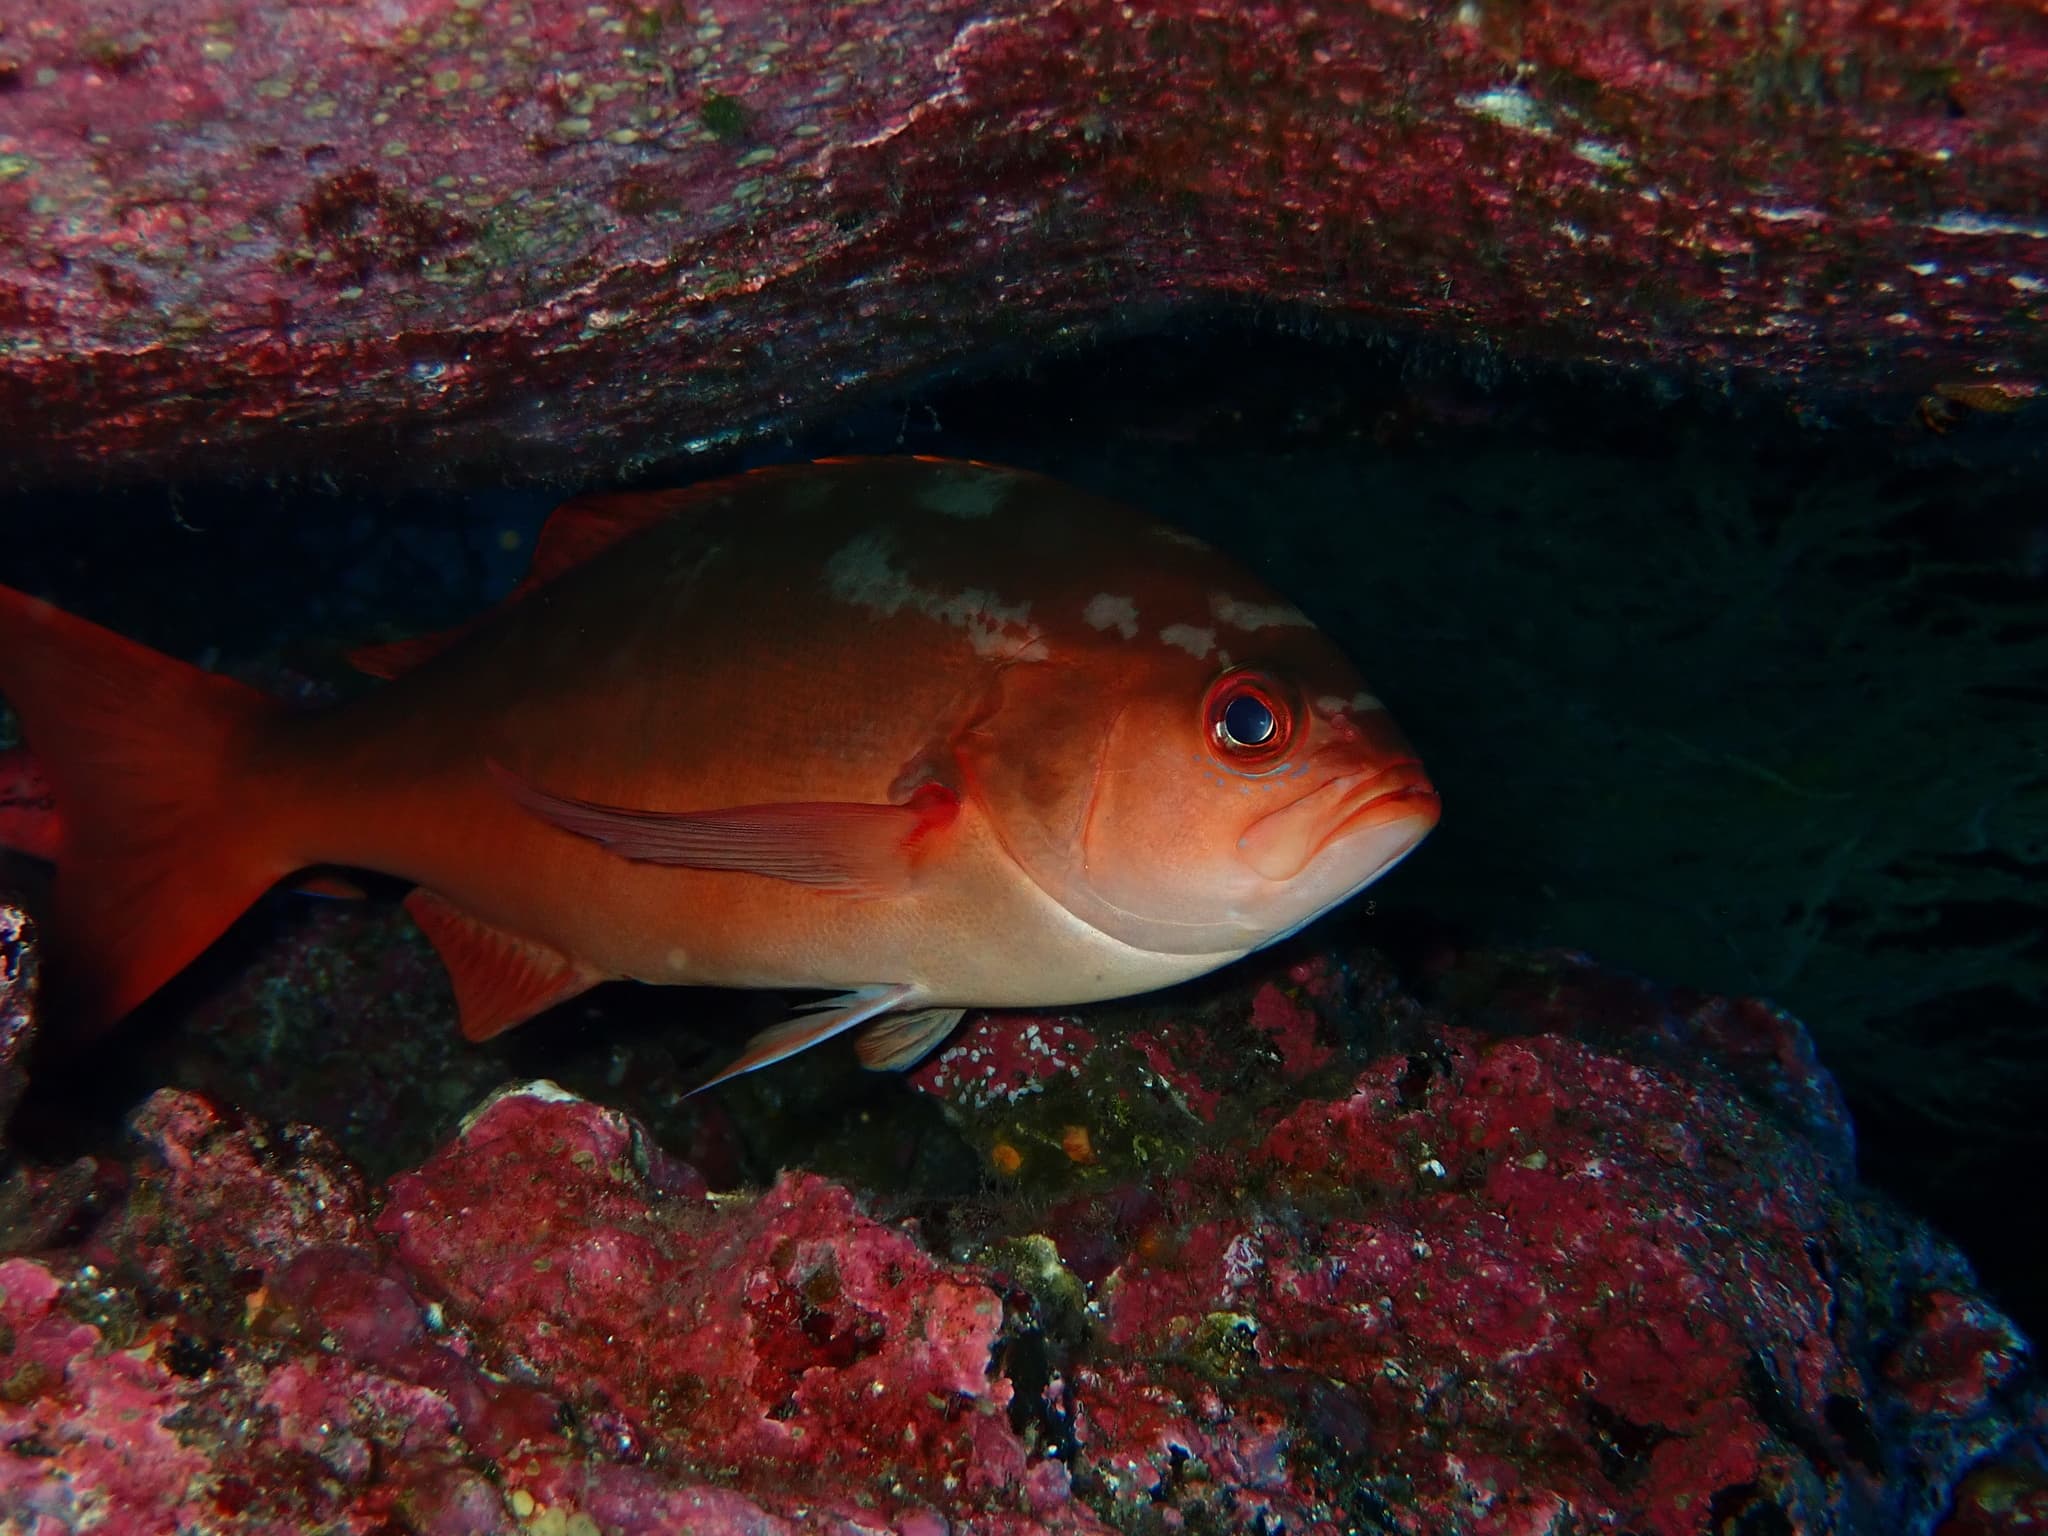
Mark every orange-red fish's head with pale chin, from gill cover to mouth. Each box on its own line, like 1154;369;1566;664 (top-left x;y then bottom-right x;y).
969;621;1440;956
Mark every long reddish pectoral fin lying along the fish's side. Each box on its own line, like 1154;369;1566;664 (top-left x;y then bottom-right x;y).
492;762;961;897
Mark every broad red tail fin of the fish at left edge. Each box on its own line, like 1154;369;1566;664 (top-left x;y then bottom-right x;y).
0;586;293;1030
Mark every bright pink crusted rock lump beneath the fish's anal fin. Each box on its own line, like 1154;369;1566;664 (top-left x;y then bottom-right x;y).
379;1085;1097;1509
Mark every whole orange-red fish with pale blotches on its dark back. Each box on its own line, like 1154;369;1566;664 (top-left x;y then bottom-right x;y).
0;457;1440;1087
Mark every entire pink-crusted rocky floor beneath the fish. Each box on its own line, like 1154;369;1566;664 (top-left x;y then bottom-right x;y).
0;913;2048;1536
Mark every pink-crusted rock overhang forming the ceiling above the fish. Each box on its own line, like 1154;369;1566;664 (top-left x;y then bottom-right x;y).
0;0;2048;483
